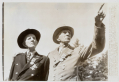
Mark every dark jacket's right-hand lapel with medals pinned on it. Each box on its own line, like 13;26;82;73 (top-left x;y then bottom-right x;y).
18;52;43;76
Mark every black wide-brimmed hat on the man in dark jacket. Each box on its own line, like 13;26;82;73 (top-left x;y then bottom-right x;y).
17;29;41;48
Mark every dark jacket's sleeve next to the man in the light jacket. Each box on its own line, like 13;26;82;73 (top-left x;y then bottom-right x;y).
43;57;50;81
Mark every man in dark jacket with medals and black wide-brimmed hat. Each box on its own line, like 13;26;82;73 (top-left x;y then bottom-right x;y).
9;29;49;81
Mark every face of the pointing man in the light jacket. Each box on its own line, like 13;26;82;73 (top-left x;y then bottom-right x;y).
57;30;71;43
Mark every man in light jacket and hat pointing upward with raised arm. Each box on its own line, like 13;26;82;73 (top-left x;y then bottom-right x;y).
48;12;105;81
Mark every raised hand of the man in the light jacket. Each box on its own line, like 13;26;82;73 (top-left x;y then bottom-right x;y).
95;11;106;27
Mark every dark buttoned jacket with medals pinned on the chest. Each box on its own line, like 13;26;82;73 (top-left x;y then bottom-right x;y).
9;53;49;81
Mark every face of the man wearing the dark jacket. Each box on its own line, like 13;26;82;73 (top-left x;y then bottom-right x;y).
24;34;38;48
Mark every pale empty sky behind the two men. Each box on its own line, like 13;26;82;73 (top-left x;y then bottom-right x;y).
4;2;109;78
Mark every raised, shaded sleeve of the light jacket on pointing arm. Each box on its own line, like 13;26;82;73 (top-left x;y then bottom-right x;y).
79;23;105;61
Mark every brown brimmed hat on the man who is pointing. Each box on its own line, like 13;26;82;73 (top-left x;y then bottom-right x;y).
53;26;74;44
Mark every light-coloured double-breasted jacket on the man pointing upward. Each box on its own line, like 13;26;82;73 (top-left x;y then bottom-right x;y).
48;25;105;81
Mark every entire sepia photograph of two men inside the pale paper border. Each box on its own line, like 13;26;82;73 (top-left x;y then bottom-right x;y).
2;2;113;81
